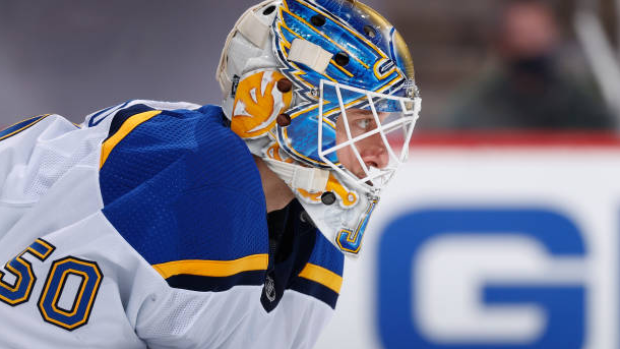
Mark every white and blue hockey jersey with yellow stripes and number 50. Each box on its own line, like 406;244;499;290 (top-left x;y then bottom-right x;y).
0;101;344;349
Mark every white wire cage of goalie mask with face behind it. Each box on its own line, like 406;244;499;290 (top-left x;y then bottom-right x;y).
318;81;420;196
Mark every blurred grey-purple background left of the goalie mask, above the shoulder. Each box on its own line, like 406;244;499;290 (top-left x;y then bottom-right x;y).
0;0;381;126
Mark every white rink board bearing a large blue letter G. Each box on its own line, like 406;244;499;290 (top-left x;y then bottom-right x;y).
317;142;620;349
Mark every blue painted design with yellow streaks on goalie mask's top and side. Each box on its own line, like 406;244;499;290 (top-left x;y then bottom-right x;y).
273;0;417;168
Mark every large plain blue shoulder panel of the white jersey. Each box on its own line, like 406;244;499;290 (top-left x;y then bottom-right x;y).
100;106;269;265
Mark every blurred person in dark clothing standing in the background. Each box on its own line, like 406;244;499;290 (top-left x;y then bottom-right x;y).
447;0;615;130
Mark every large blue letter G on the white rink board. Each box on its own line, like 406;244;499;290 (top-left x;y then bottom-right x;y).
377;208;586;349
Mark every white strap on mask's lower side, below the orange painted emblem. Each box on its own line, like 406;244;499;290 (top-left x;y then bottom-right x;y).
263;158;329;193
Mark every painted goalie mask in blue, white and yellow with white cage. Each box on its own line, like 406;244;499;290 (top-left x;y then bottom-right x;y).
217;0;421;255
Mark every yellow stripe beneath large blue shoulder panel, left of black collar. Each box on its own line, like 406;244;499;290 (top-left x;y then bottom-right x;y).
153;254;269;279
